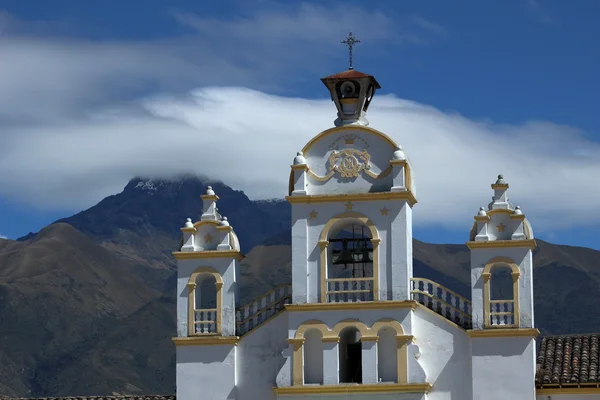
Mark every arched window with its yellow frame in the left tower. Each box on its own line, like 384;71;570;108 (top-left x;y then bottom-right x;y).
188;268;223;336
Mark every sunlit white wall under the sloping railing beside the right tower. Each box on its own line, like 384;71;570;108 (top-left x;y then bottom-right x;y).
412;307;474;400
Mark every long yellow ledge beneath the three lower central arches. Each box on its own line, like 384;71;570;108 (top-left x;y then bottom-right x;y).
273;383;433;396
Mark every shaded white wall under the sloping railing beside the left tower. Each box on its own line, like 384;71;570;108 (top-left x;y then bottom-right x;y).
236;312;288;400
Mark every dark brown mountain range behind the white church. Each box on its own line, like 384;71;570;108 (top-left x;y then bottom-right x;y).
0;175;600;397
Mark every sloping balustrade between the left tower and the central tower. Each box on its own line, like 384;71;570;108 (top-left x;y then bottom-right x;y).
235;283;292;336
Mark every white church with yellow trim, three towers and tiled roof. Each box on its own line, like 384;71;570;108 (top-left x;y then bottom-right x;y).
173;64;600;400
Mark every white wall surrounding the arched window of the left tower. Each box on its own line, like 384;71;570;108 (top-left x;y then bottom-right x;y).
177;258;237;337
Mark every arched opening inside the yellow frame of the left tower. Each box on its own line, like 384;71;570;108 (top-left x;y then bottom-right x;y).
193;273;217;335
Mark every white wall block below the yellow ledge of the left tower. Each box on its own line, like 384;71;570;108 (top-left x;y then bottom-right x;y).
175;345;238;400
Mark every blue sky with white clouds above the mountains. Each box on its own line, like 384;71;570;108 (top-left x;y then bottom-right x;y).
0;0;600;249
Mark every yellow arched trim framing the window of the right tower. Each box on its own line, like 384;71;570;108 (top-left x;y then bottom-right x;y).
481;257;521;329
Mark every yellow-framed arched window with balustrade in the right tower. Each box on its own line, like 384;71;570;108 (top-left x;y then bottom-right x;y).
482;257;520;328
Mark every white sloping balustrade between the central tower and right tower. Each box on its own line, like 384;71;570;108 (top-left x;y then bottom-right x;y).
410;278;472;329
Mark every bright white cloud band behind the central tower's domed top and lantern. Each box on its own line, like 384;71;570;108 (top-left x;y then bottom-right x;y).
0;87;600;233
